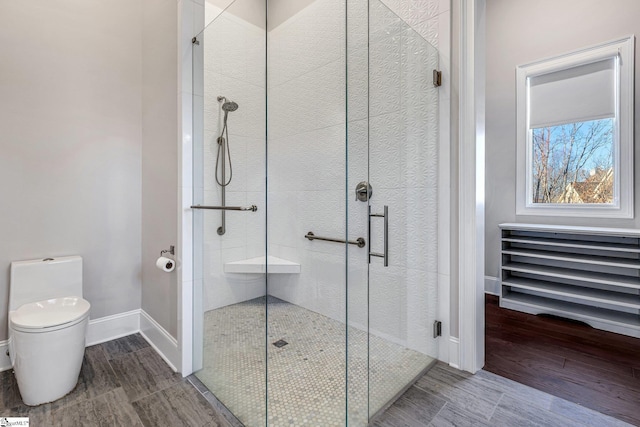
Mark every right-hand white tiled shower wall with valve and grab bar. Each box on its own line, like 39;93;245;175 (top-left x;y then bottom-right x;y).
268;0;440;355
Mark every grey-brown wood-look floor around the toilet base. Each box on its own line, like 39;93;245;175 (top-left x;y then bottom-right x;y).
0;334;232;427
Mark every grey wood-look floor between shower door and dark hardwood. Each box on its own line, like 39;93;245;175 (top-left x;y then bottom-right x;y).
373;362;629;427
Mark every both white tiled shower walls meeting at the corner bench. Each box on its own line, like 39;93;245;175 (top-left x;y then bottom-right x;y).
203;0;448;355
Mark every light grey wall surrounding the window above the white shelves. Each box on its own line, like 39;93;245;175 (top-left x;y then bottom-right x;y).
485;0;640;277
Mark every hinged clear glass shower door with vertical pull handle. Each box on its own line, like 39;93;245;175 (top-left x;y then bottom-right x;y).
367;0;438;417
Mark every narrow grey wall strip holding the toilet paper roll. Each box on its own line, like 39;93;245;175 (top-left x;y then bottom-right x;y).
141;0;178;338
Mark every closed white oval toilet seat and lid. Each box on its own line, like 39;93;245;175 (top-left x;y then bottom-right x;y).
9;296;91;333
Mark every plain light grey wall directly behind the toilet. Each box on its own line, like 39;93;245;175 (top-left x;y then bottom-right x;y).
0;0;142;339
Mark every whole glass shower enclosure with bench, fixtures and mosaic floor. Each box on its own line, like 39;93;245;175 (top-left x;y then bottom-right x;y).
193;0;438;426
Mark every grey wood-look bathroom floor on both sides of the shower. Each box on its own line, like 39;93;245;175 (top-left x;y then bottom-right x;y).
0;334;627;427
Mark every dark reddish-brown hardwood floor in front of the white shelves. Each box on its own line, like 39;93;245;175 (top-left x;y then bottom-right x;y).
484;295;640;425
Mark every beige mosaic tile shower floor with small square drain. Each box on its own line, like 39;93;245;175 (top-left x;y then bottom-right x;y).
196;297;434;427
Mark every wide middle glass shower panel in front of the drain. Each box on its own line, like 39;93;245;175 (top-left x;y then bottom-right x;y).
267;0;350;427
